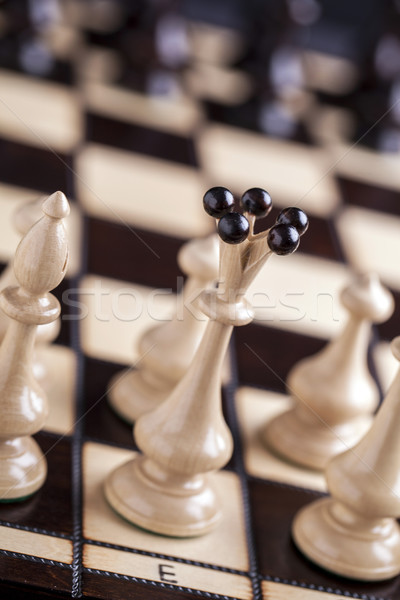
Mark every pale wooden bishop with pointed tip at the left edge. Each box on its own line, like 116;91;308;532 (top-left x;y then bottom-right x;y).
0;192;69;502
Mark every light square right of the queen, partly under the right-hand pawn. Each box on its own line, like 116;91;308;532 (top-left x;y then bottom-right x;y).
236;387;326;491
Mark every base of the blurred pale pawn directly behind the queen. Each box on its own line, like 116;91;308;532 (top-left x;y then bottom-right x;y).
108;369;167;424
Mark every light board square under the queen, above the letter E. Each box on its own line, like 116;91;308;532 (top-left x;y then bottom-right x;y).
83;442;249;573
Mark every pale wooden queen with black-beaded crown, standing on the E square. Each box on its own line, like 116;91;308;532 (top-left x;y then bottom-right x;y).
105;188;304;537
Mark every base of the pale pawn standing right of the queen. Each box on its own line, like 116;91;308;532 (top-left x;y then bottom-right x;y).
262;407;372;470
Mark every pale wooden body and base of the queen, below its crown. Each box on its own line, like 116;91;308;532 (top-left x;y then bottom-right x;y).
105;247;251;537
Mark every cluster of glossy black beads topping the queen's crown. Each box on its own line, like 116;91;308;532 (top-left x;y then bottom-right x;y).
203;187;308;255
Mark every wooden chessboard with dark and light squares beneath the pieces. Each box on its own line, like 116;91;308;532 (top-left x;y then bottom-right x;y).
0;1;400;600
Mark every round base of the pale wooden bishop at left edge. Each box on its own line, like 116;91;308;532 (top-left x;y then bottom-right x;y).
0;436;47;502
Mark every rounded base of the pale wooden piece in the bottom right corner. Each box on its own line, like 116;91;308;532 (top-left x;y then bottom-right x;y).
292;498;400;581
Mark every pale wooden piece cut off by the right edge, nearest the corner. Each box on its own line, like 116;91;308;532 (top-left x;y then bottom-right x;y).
292;337;400;581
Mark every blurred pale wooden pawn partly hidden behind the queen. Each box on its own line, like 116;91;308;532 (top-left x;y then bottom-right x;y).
108;235;218;423
